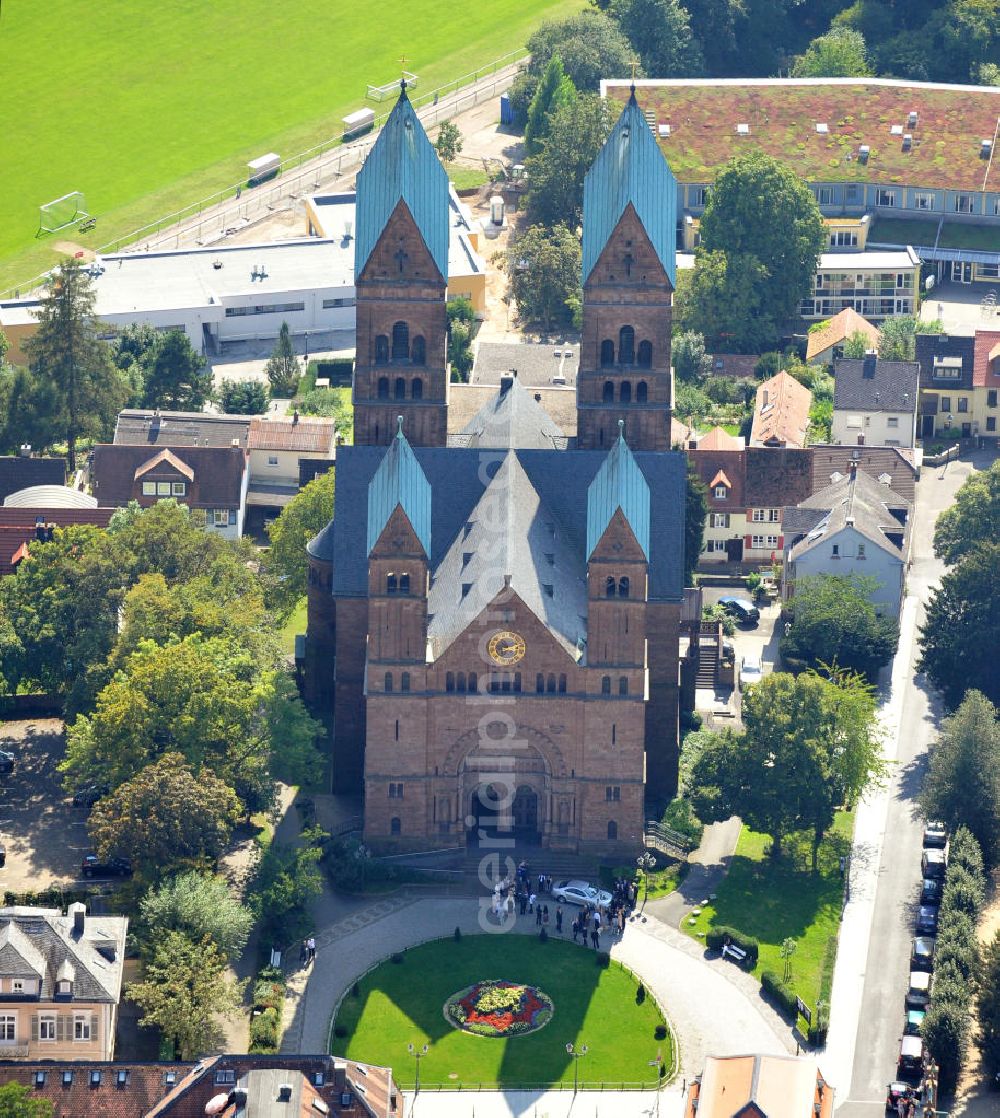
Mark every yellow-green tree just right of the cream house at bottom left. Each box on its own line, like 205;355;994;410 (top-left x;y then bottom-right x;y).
128;931;246;1060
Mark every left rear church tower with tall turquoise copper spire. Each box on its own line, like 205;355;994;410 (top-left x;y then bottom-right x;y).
353;83;449;446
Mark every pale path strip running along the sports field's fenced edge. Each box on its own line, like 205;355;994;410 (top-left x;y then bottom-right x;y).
0;47;528;297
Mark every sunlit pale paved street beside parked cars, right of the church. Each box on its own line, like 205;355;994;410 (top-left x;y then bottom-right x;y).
837;455;989;1118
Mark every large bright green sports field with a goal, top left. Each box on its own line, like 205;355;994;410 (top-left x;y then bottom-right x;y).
0;0;583;291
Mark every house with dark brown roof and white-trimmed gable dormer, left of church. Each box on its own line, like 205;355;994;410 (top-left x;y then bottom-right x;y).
93;444;249;540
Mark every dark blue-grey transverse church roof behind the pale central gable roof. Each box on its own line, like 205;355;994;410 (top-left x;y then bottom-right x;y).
333;446;684;601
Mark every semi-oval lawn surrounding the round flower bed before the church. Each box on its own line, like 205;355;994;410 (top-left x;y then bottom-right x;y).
333;939;672;1088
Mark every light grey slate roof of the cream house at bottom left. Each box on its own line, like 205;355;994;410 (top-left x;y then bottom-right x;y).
0;908;129;1004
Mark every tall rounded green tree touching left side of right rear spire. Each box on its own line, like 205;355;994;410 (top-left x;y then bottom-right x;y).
527;94;611;229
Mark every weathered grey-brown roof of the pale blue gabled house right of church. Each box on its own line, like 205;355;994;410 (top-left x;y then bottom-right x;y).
785;470;913;561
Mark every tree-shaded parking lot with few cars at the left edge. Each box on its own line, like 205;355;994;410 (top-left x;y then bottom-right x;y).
0;718;89;892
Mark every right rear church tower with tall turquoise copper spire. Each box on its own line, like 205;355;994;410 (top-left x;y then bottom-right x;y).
576;88;677;451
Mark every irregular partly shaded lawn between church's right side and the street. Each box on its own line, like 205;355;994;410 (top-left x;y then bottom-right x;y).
682;812;855;1007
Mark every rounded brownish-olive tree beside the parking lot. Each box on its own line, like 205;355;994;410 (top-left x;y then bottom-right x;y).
87;752;239;878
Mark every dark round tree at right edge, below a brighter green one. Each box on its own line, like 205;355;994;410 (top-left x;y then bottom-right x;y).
919;542;1000;709
